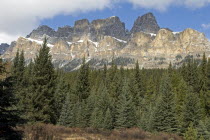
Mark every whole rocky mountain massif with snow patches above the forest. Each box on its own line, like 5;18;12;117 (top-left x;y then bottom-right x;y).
2;13;210;71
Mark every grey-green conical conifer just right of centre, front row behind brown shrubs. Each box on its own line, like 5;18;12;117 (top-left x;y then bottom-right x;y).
116;80;136;128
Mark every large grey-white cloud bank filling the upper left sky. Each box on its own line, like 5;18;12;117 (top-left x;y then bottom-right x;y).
0;0;115;43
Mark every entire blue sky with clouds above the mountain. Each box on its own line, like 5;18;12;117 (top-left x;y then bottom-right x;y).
0;0;210;43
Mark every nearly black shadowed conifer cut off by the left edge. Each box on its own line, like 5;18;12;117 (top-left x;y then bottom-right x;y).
0;59;20;140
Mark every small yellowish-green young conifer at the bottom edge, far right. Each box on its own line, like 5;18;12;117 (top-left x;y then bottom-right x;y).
184;123;198;140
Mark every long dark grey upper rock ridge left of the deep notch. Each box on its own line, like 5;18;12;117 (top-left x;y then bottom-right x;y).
27;17;126;42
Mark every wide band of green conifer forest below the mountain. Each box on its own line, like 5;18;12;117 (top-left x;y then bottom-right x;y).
0;39;210;140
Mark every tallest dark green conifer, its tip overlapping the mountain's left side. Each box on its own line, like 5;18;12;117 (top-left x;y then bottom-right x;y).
28;38;55;123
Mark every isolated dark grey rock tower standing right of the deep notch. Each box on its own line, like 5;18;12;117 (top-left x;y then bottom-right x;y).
131;13;160;34
